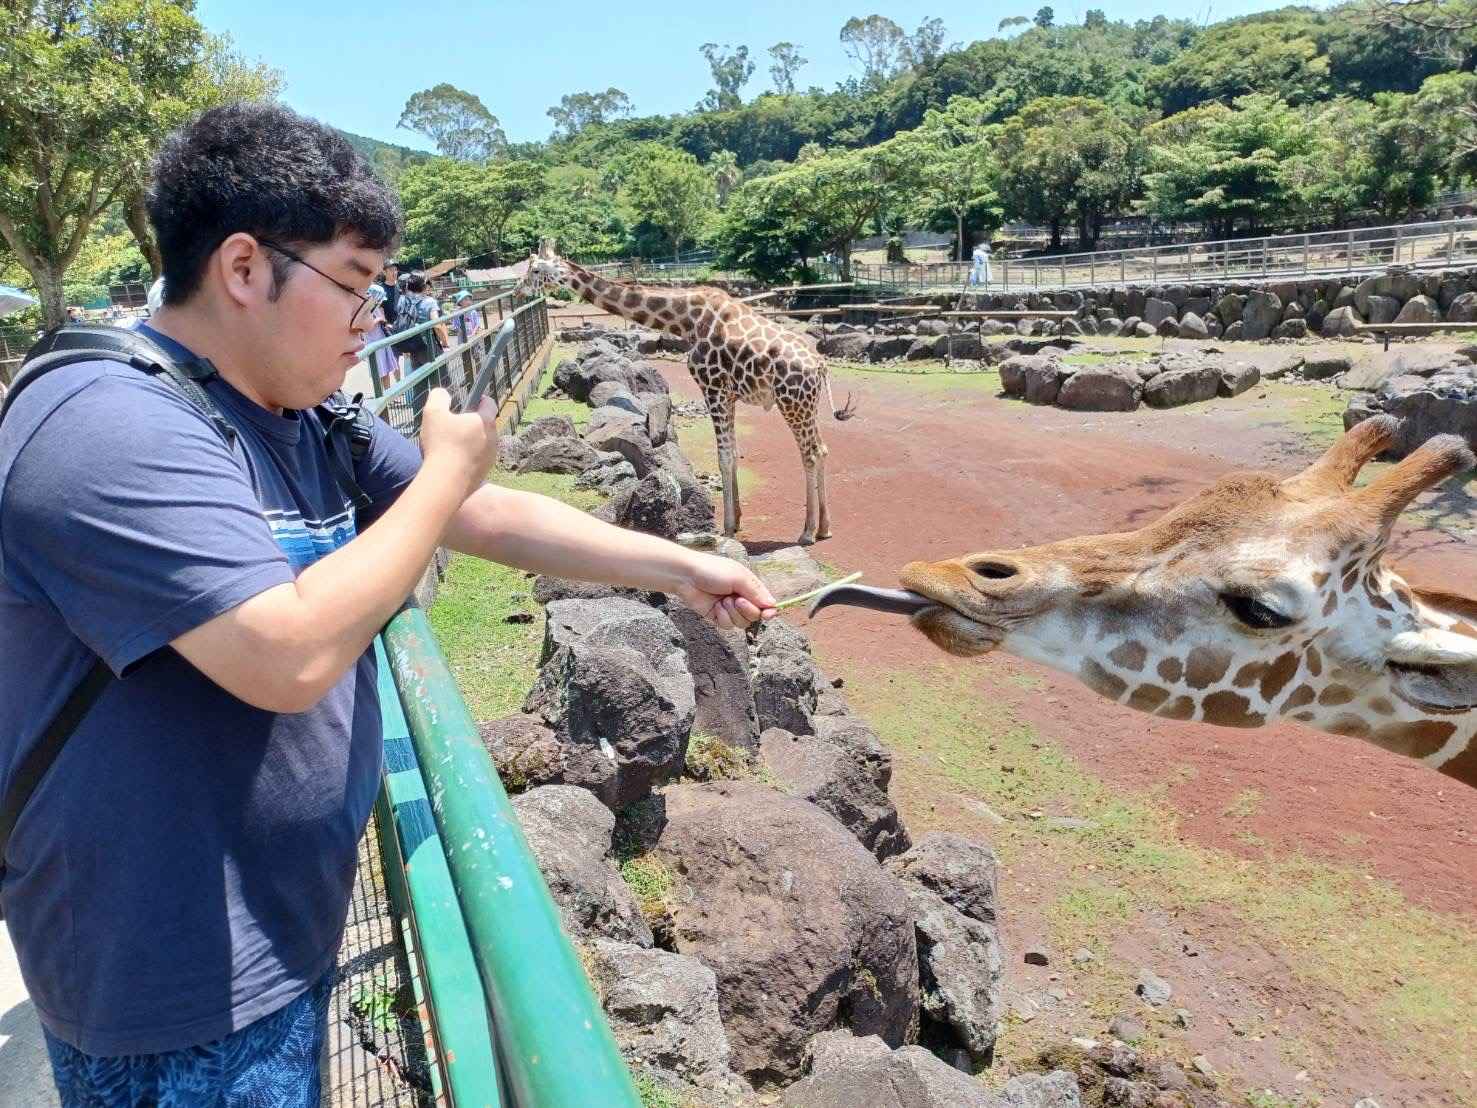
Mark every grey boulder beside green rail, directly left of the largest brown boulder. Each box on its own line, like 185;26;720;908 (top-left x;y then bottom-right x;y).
513;784;653;947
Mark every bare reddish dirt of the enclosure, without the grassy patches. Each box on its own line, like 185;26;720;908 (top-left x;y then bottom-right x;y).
665;362;1477;916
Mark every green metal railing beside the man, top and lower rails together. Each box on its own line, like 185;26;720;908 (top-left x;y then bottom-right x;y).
378;606;641;1108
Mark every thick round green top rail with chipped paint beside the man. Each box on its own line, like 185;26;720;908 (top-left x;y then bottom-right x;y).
383;606;641;1108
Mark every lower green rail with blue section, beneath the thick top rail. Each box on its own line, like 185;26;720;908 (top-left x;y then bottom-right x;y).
375;640;504;1108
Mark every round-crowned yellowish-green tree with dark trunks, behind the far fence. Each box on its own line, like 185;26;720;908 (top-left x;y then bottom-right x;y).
994;96;1140;250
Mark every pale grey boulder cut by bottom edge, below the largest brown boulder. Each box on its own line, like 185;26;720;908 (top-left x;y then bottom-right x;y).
780;1031;1001;1108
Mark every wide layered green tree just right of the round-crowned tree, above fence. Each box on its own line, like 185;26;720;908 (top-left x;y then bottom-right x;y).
1143;95;1315;238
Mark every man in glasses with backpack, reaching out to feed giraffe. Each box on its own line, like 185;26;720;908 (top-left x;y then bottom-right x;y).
0;103;774;1108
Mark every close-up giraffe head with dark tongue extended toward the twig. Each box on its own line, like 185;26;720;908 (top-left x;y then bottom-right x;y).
815;417;1477;784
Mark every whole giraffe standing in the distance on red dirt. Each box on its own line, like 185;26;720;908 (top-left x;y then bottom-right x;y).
523;241;854;545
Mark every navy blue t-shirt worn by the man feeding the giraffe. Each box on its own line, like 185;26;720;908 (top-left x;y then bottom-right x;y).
0;328;419;1055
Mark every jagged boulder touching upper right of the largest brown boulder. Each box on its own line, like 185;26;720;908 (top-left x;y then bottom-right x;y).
759;717;908;858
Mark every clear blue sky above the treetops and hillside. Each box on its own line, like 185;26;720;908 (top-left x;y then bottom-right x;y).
196;0;1305;148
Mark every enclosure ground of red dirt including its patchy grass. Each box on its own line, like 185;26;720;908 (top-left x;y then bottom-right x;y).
649;336;1477;1108
